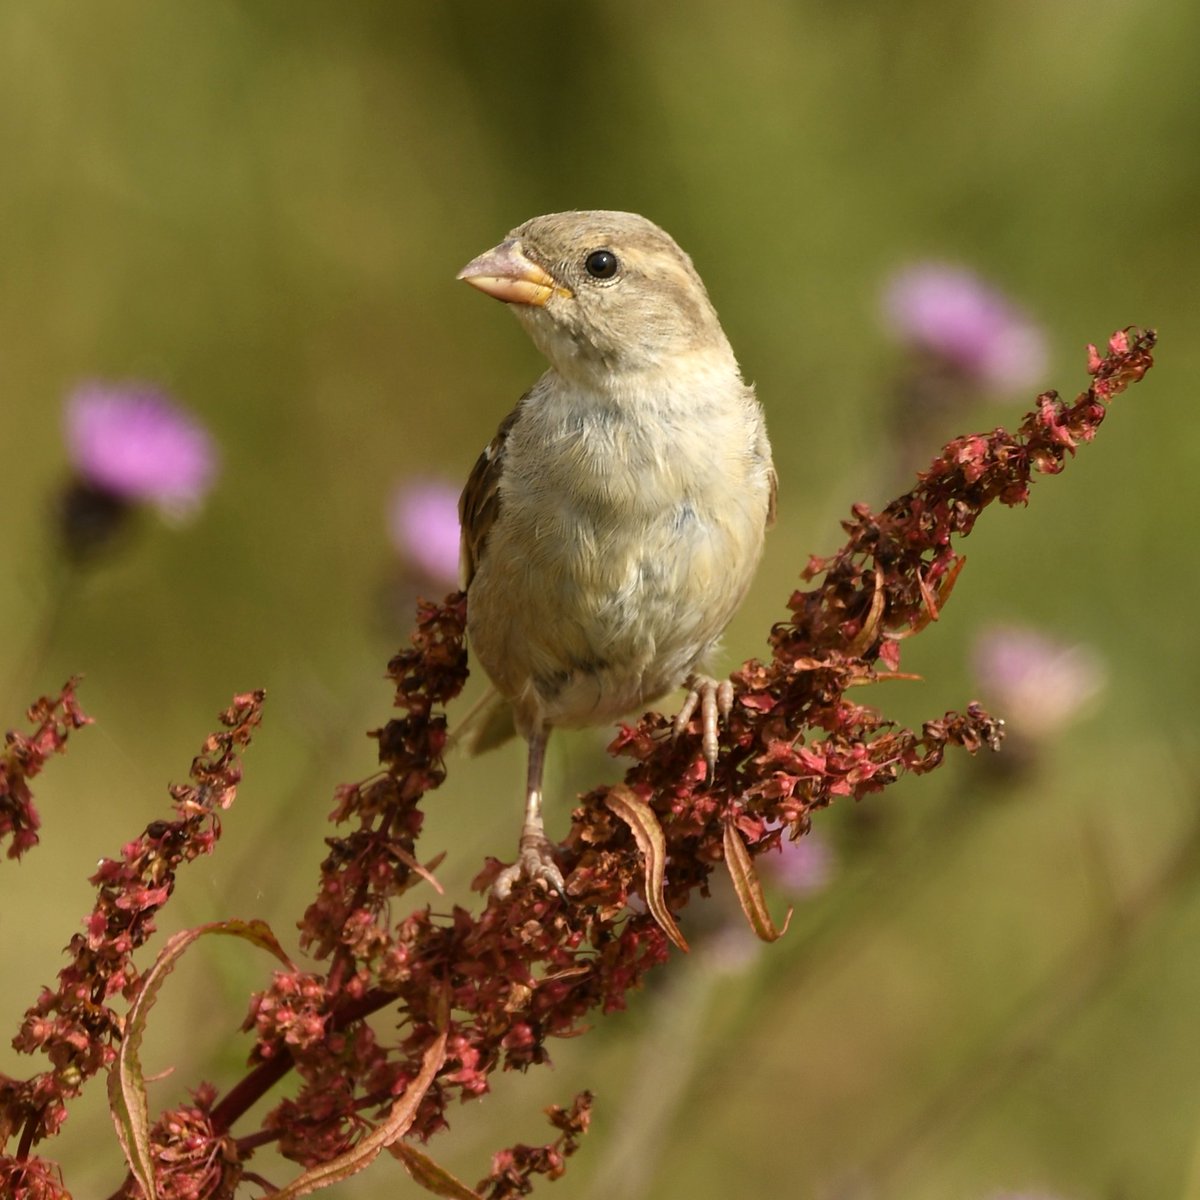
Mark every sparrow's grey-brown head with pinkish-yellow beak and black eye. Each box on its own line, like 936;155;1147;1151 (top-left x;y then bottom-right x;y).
458;211;732;384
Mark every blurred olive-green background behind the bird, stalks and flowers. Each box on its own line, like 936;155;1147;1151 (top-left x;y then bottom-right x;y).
0;0;1200;1200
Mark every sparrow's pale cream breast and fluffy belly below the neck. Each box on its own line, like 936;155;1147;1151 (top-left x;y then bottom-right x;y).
469;374;769;725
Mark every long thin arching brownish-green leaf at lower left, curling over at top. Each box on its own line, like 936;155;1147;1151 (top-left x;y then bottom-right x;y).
108;920;292;1200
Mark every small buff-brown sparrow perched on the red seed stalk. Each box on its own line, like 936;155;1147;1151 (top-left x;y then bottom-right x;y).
458;211;775;896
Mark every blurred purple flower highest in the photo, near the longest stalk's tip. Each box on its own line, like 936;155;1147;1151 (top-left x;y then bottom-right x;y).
883;263;1046;388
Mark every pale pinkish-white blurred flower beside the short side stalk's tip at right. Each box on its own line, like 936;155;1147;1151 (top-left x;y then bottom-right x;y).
973;625;1106;738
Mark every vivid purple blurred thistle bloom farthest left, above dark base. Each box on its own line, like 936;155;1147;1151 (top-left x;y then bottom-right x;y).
65;383;217;515
